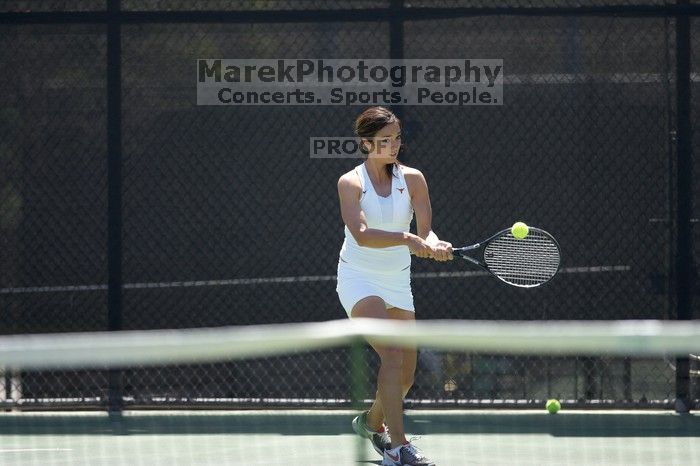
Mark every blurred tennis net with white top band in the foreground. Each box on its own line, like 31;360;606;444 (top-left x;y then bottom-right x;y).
0;319;700;466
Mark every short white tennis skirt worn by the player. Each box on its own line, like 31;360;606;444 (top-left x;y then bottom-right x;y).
336;260;415;316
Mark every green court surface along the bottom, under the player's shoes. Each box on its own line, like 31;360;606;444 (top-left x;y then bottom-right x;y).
0;410;700;466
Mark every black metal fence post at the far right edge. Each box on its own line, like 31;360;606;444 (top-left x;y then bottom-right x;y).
675;0;695;413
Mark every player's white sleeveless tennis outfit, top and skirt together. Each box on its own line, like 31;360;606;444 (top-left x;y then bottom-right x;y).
336;163;415;315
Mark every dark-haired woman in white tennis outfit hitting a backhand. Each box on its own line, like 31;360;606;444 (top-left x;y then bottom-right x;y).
337;107;452;466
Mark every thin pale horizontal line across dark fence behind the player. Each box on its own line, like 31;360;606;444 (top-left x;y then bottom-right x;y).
0;265;632;295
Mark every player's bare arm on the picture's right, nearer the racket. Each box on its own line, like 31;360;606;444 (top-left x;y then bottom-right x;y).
403;167;452;261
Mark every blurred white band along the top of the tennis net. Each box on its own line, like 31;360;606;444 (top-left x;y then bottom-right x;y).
0;319;700;370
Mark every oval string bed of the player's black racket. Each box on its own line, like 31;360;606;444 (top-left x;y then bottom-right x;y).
484;230;560;287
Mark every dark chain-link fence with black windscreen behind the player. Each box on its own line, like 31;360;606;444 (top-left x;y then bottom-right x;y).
0;0;700;407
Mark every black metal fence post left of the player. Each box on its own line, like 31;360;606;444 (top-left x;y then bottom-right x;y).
107;0;123;413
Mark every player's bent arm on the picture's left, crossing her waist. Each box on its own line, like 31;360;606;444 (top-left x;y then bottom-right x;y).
338;171;432;257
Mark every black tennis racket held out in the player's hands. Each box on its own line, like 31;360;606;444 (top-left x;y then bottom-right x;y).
452;227;561;288
